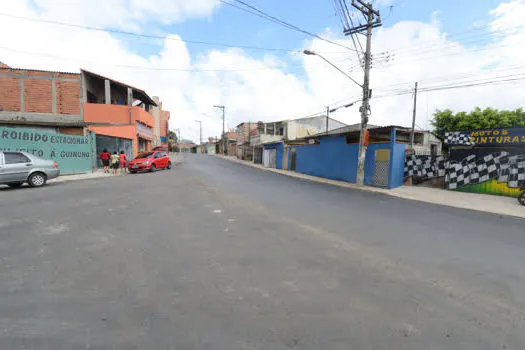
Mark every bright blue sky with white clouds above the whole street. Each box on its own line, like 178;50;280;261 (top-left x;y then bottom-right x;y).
0;0;525;141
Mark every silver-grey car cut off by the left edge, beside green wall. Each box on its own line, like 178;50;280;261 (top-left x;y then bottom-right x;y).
0;151;60;188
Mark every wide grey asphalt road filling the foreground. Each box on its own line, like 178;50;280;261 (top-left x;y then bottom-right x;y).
0;155;525;350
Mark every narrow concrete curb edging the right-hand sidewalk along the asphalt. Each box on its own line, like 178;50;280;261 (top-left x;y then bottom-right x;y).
216;155;525;220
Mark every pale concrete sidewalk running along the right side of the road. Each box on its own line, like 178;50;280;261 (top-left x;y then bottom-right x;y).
217;155;525;218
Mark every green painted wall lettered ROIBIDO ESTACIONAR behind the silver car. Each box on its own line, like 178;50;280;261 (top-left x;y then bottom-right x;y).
0;127;96;174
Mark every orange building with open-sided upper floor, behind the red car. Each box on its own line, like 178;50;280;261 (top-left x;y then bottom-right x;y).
81;70;157;158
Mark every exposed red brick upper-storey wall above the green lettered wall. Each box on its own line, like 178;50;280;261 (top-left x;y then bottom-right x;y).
0;68;80;115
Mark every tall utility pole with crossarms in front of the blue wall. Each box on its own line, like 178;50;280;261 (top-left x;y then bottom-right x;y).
344;0;381;185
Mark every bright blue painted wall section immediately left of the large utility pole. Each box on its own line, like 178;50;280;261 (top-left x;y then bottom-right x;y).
296;136;359;182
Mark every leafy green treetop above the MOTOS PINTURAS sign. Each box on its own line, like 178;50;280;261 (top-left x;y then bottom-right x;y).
432;107;525;137
